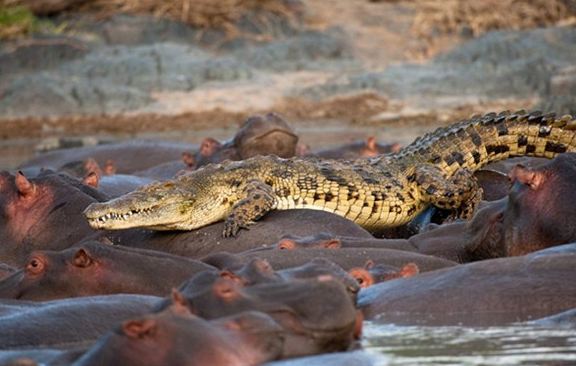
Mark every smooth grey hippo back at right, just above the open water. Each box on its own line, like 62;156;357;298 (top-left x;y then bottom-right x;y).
358;244;576;326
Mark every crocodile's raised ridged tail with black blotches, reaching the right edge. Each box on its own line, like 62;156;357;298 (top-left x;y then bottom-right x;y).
397;111;576;175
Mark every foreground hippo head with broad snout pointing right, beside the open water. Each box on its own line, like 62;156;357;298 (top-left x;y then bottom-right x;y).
164;275;362;358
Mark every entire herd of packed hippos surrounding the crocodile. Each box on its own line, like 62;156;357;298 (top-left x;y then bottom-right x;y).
0;113;576;366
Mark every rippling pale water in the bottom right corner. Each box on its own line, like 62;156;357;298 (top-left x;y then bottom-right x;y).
363;322;576;366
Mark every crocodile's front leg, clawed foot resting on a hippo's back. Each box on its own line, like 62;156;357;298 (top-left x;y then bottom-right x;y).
222;180;276;237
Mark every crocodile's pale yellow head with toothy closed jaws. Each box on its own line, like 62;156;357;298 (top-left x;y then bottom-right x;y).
84;167;231;230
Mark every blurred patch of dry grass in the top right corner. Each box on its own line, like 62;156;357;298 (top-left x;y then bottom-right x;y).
412;0;576;38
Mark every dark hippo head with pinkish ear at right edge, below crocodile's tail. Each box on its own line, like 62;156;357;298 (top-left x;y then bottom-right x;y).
504;153;576;256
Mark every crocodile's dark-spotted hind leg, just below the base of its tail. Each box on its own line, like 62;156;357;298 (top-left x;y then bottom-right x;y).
414;165;483;219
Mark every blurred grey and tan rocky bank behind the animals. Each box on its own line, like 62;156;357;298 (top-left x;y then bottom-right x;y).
0;0;576;167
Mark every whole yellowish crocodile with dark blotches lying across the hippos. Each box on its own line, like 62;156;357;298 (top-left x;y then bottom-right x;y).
84;111;576;237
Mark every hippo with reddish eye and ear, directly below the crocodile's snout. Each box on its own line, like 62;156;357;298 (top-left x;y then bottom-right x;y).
0;241;214;301
